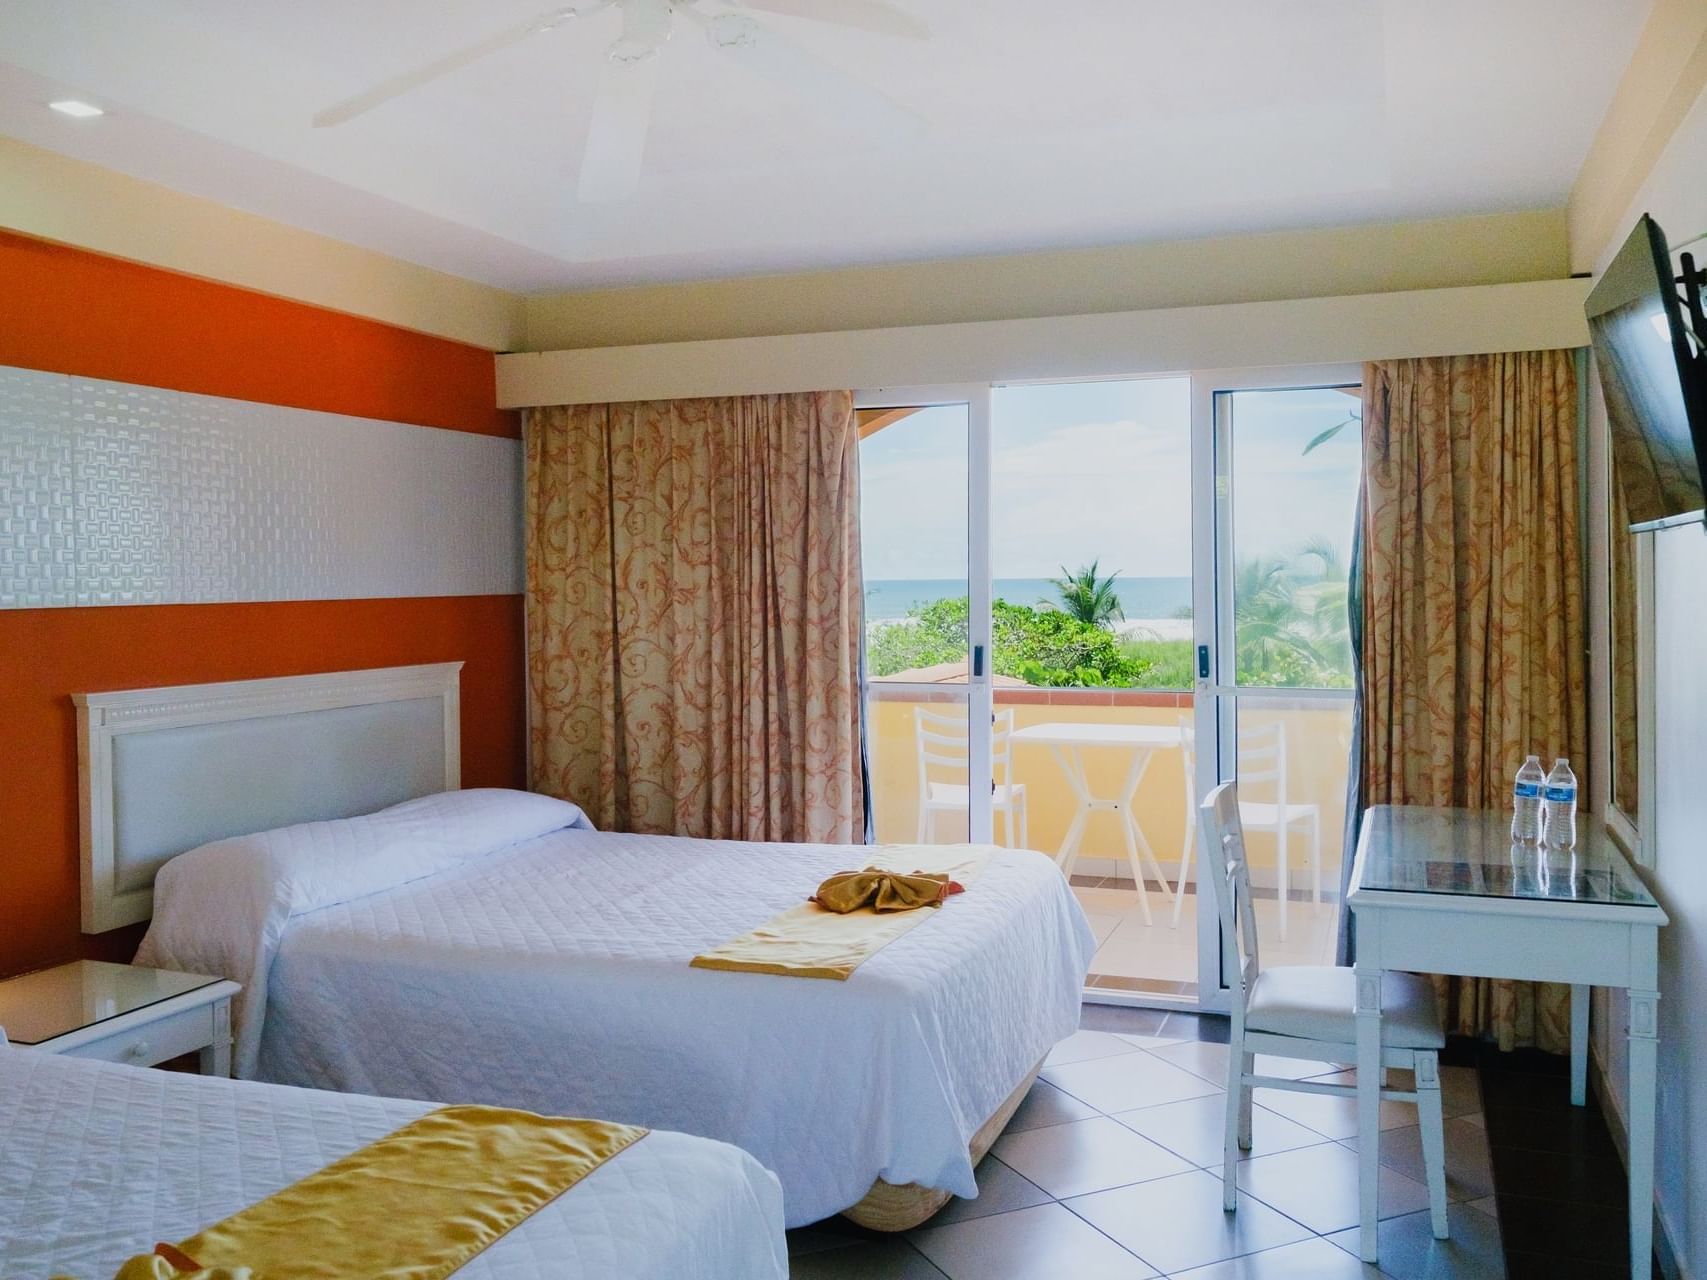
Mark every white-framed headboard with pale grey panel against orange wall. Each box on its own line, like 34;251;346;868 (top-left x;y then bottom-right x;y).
72;662;463;934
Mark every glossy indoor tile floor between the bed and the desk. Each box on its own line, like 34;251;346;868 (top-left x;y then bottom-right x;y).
789;1014;1504;1280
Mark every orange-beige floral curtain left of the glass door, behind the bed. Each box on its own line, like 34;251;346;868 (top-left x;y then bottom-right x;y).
526;391;864;843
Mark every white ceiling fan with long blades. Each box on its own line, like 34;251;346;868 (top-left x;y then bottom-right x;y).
314;0;930;203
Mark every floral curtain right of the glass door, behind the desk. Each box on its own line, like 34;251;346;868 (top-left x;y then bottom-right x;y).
1360;352;1588;1051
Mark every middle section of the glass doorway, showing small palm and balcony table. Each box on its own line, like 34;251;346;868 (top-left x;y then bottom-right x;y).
990;377;1198;1000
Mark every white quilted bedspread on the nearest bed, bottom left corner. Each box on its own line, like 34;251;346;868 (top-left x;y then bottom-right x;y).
0;1048;789;1280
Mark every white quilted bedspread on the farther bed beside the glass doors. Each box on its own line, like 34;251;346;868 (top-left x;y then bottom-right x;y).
133;797;1094;1225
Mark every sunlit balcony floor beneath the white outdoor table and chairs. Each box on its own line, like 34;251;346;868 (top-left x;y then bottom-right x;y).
1072;876;1338;995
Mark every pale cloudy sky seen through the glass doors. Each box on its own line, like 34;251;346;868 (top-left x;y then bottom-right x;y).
860;377;1359;580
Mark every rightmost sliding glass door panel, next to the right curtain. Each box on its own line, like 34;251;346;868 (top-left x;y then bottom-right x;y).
1193;367;1362;993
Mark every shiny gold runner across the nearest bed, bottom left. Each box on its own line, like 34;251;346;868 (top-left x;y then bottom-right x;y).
81;1106;647;1280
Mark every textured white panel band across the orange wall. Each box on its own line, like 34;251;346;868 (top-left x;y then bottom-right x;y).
0;367;522;609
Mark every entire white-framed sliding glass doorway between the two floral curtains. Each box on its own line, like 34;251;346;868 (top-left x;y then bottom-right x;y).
859;369;1362;1007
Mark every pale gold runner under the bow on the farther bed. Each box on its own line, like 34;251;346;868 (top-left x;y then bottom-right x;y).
690;845;990;981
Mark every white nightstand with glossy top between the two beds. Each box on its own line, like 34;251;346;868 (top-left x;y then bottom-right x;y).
0;961;242;1075
